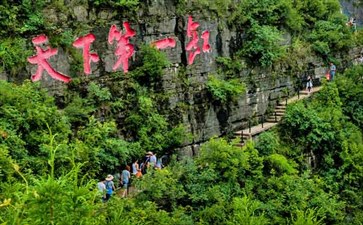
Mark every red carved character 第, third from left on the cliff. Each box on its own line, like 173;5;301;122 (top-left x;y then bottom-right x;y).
108;22;136;73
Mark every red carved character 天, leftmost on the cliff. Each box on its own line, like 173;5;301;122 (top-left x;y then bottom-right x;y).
28;35;71;83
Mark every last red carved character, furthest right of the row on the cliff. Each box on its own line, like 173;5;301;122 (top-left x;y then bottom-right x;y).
185;16;211;65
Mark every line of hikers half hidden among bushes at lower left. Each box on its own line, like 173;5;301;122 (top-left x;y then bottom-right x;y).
97;151;165;202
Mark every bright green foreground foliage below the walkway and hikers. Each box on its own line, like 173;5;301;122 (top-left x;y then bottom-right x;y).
0;66;363;225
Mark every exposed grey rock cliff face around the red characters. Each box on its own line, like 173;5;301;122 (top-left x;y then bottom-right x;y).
1;0;352;154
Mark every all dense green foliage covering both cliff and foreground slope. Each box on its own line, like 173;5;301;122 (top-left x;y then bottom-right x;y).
0;0;363;225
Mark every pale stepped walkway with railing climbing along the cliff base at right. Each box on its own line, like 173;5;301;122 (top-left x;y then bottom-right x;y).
234;87;321;146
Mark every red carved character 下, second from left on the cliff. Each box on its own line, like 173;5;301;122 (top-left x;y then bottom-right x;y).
73;34;100;75
